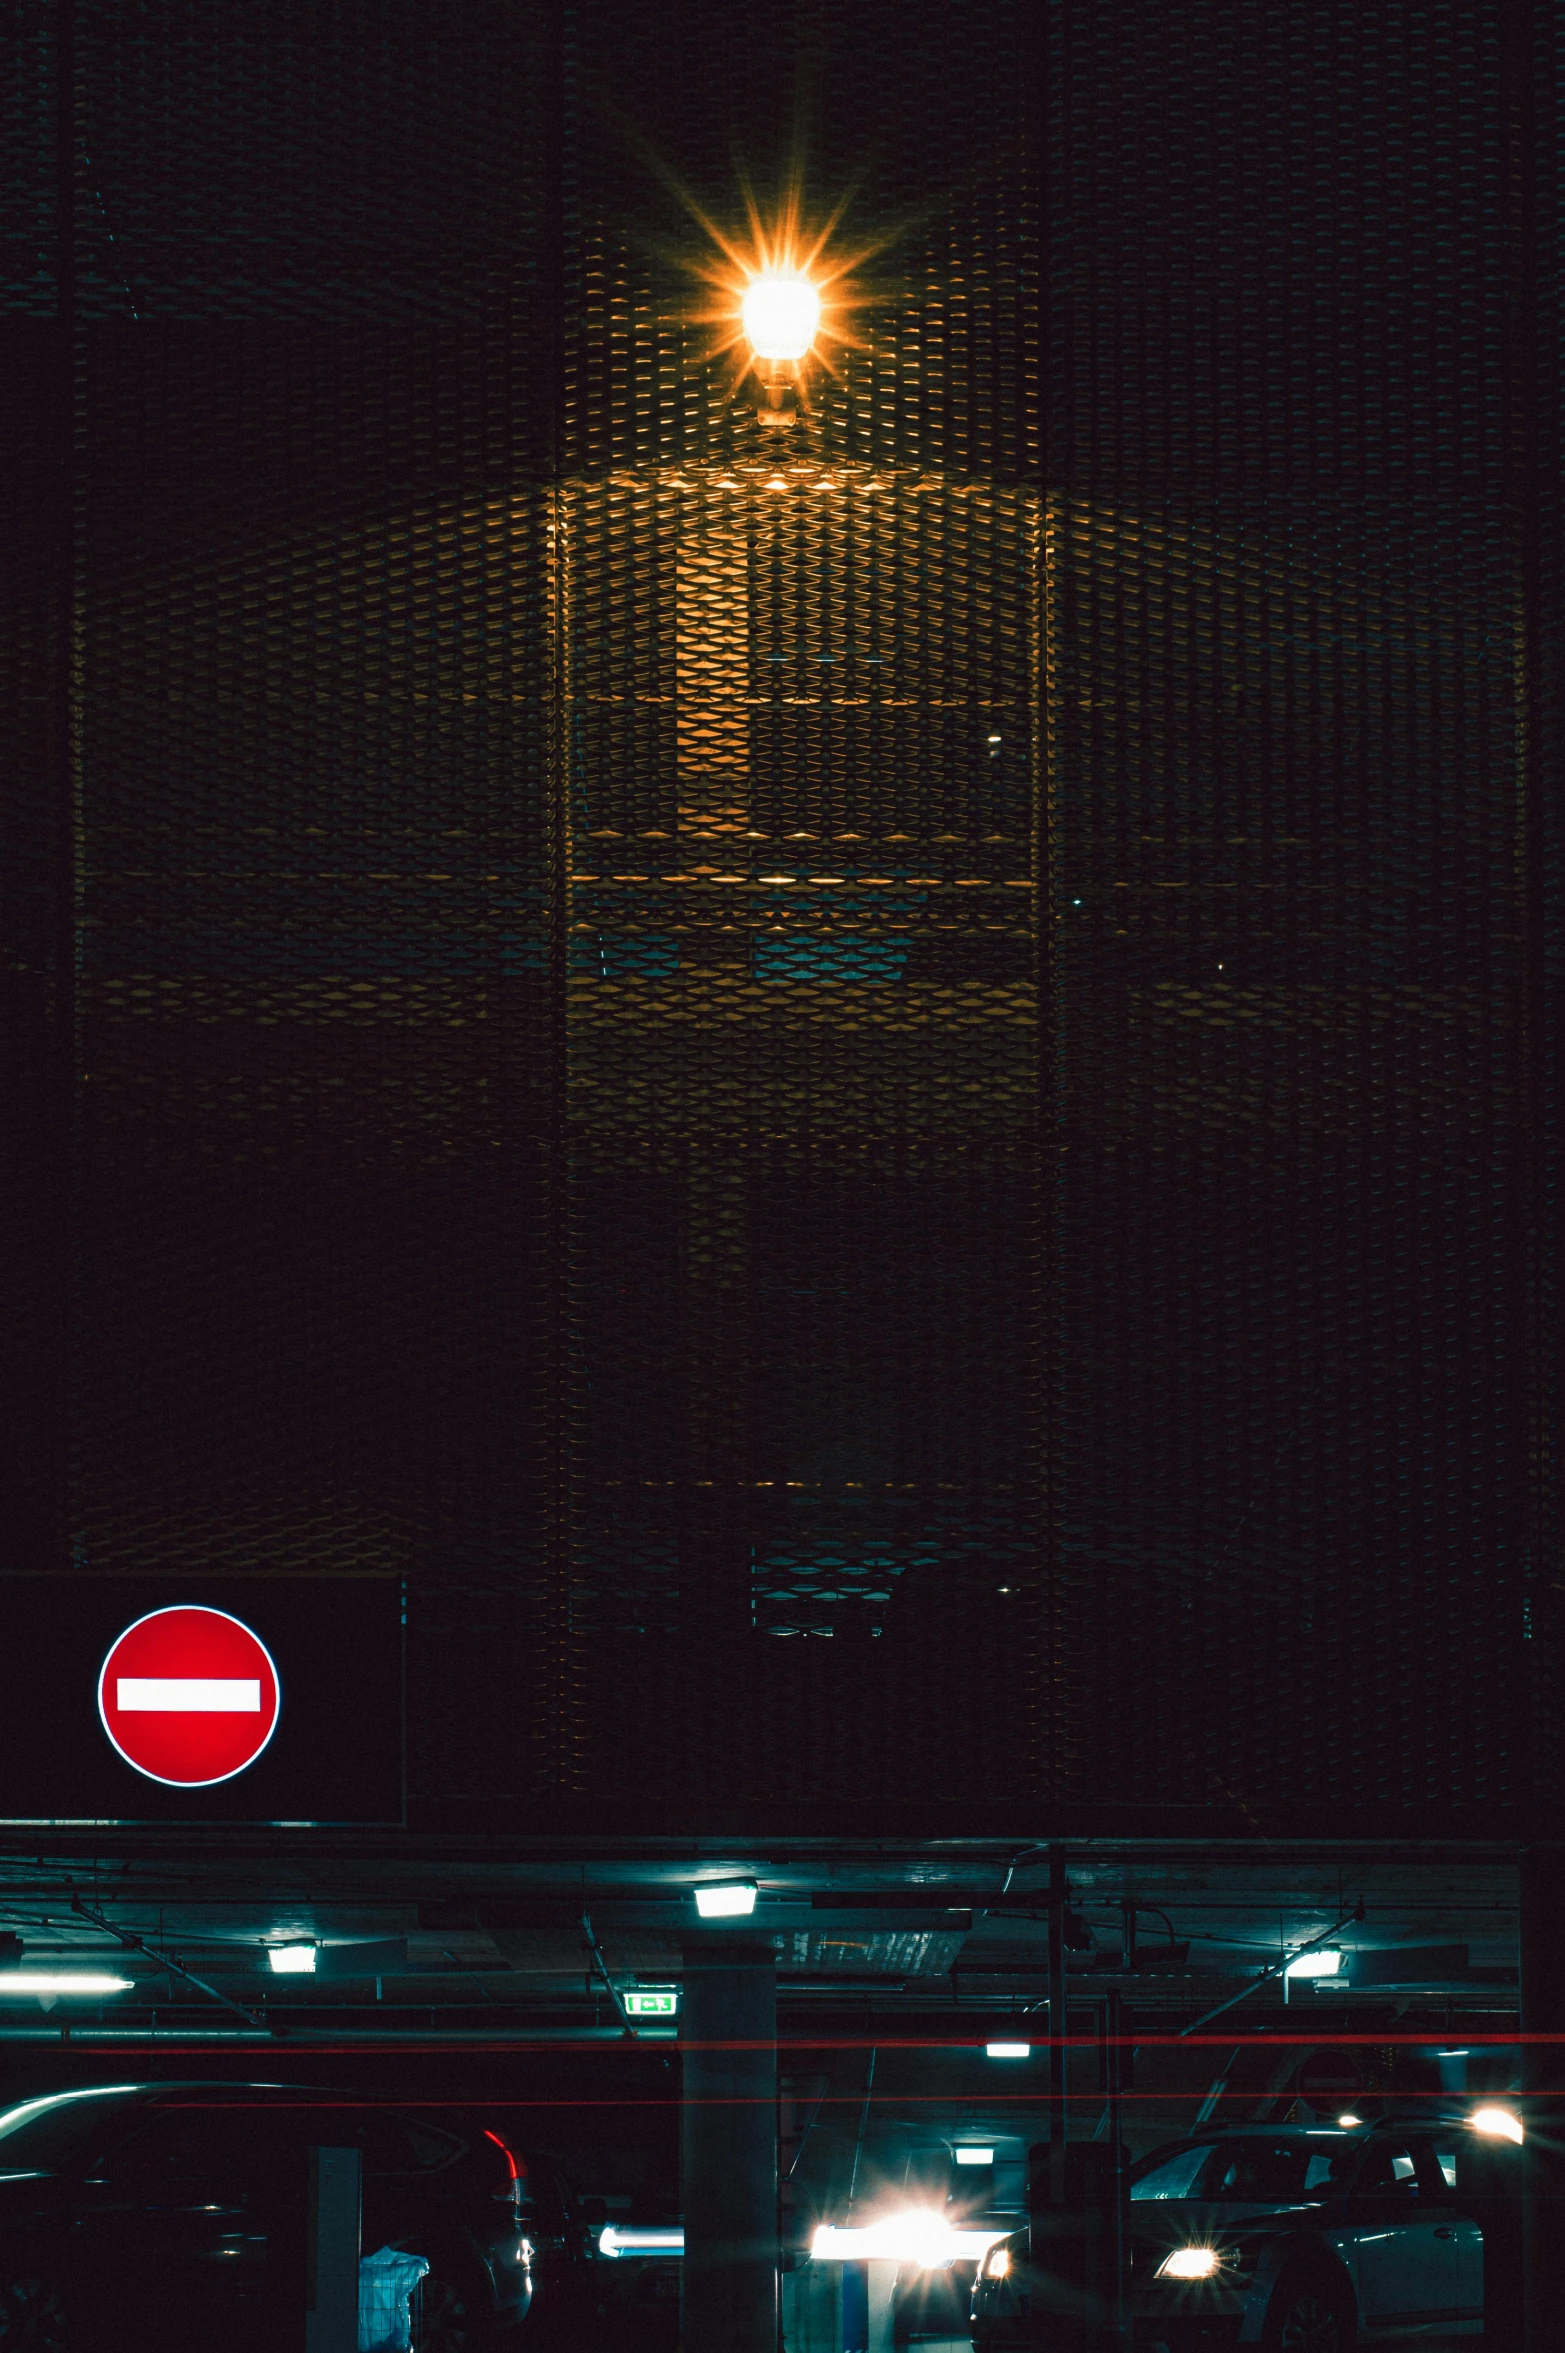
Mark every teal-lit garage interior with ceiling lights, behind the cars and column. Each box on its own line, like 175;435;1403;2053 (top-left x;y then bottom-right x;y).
0;1840;1527;2353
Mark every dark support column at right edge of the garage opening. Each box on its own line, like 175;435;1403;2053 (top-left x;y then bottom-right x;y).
1494;1847;1565;2353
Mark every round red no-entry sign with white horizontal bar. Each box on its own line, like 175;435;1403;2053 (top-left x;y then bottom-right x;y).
99;1605;282;1788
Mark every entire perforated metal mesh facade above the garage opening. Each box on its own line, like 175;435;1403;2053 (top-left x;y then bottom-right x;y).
5;0;1558;1833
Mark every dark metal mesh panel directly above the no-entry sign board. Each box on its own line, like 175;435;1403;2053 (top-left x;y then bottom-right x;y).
51;7;551;1791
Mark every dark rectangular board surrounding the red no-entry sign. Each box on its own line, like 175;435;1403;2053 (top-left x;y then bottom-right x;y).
0;1577;402;1824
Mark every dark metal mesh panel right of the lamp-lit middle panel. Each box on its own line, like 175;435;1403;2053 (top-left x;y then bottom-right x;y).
1045;5;1527;1824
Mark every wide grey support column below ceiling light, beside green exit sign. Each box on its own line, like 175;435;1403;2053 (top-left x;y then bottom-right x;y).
680;1934;777;2353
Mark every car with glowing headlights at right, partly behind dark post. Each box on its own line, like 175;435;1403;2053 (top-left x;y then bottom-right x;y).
972;2118;1509;2353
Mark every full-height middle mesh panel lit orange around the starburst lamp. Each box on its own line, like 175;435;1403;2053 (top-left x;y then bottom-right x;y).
560;5;1043;1807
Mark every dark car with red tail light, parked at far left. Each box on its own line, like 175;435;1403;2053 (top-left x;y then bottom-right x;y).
0;2082;586;2353
